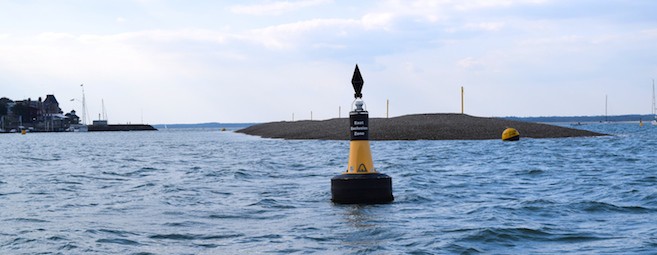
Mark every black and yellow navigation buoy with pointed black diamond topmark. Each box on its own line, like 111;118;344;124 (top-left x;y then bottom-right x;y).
331;65;394;204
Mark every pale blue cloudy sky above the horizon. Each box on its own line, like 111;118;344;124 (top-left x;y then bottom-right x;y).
0;0;657;124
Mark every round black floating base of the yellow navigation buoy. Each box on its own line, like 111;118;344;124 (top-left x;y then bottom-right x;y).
331;173;394;204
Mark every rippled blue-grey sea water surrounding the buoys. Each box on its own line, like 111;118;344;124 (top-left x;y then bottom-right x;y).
0;124;657;254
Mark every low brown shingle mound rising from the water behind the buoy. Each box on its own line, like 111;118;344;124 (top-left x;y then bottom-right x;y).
237;113;605;140
